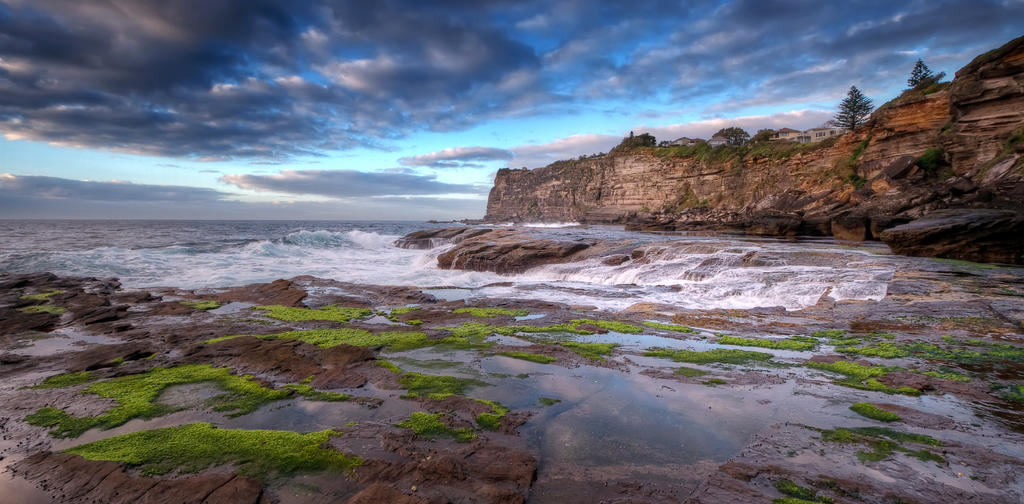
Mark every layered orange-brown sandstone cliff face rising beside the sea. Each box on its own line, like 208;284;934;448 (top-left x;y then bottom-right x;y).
485;37;1024;260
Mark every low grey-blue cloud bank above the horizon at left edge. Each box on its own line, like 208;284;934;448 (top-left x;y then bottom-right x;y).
0;173;231;203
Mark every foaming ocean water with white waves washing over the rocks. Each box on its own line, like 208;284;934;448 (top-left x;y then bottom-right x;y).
0;220;897;309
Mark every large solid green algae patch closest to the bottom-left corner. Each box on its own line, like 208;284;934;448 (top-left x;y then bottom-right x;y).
66;423;362;480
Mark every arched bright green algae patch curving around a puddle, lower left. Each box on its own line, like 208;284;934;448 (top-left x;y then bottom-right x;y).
25;365;292;437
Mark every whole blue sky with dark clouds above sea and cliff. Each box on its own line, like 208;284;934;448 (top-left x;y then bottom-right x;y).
0;0;1024;220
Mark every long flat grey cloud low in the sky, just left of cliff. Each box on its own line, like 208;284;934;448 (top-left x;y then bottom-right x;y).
220;170;481;198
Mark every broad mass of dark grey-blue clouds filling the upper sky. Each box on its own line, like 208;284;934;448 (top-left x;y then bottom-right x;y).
0;0;1024;160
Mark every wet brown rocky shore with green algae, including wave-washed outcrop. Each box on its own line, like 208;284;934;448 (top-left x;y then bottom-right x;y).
6;227;1024;504
